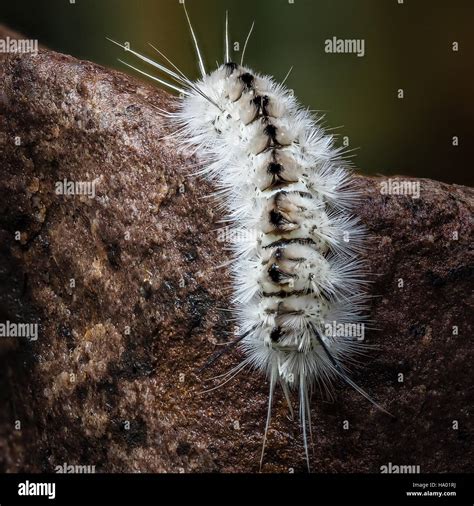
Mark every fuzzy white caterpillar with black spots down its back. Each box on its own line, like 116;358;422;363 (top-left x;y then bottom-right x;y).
109;0;390;470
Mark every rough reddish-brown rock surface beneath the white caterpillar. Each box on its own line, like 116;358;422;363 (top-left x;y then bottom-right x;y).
0;41;474;472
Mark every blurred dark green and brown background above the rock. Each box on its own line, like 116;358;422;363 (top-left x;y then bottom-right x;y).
0;0;474;184
